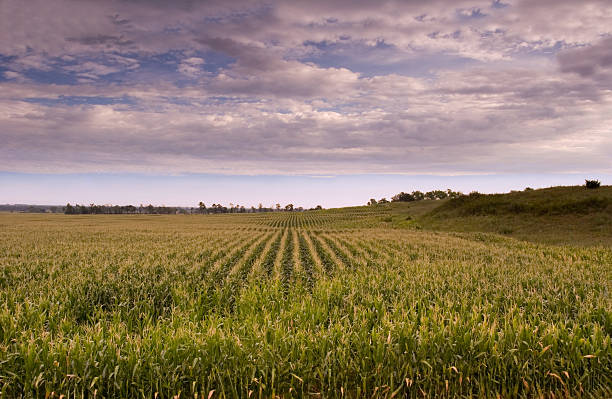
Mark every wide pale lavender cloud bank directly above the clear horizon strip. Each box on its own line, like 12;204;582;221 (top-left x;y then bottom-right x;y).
0;60;612;174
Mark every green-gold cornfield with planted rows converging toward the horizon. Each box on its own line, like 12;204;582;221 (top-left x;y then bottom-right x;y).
0;205;612;398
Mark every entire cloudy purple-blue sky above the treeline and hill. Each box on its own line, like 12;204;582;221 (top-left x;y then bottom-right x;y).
0;0;612;207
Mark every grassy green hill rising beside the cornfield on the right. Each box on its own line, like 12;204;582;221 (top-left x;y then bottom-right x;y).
412;186;612;246
